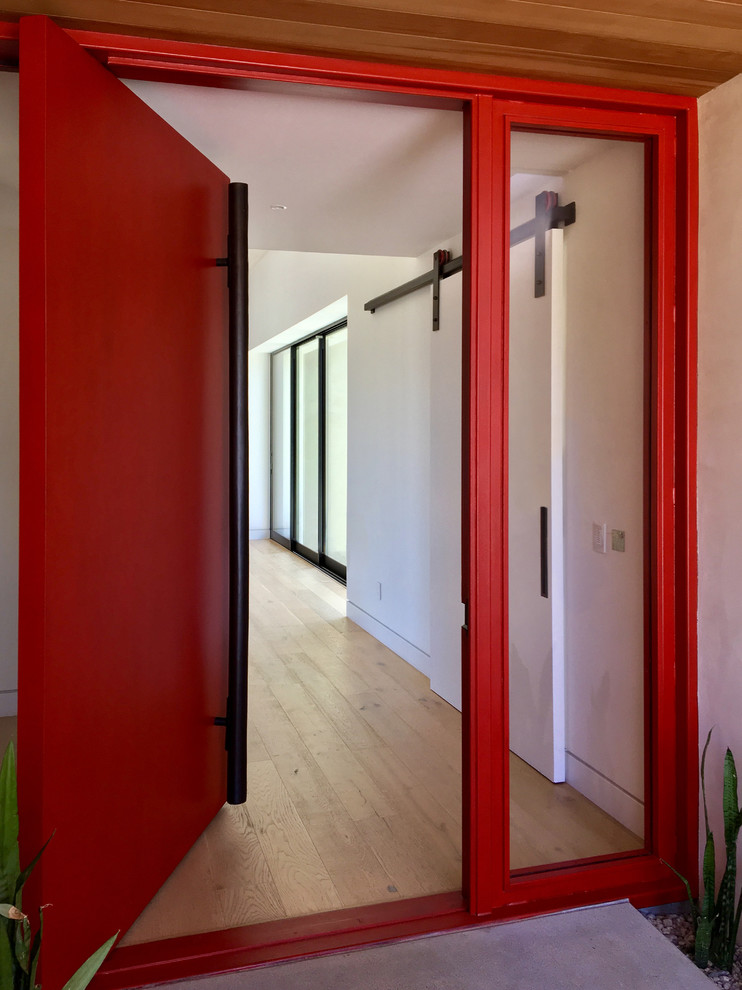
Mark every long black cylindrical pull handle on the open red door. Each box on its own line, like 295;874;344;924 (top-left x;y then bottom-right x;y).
214;182;249;804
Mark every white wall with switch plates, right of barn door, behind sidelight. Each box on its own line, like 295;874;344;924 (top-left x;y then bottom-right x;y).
563;142;645;835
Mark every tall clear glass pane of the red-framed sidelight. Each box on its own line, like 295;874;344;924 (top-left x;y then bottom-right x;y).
508;133;648;869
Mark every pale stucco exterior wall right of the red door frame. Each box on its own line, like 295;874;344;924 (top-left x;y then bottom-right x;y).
698;76;742;884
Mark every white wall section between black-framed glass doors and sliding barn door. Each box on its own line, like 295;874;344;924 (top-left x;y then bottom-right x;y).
348;257;431;676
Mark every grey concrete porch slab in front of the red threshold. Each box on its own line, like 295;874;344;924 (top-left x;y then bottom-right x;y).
164;901;713;990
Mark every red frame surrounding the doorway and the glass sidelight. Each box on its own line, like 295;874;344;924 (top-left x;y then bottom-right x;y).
0;24;698;990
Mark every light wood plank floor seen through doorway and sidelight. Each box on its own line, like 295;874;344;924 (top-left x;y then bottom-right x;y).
122;541;641;944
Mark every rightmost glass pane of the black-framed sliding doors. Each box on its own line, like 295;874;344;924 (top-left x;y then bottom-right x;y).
324;327;348;564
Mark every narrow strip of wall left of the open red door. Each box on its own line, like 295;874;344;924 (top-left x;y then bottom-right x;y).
0;72;18;716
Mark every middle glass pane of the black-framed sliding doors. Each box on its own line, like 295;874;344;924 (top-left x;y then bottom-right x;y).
295;338;320;553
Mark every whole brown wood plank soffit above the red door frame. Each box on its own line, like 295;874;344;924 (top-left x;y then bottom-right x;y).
0;0;742;96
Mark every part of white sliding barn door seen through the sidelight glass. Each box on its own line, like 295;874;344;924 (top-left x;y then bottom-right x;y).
508;223;565;782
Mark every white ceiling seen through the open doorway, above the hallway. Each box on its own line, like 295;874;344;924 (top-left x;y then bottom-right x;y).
127;81;463;257
